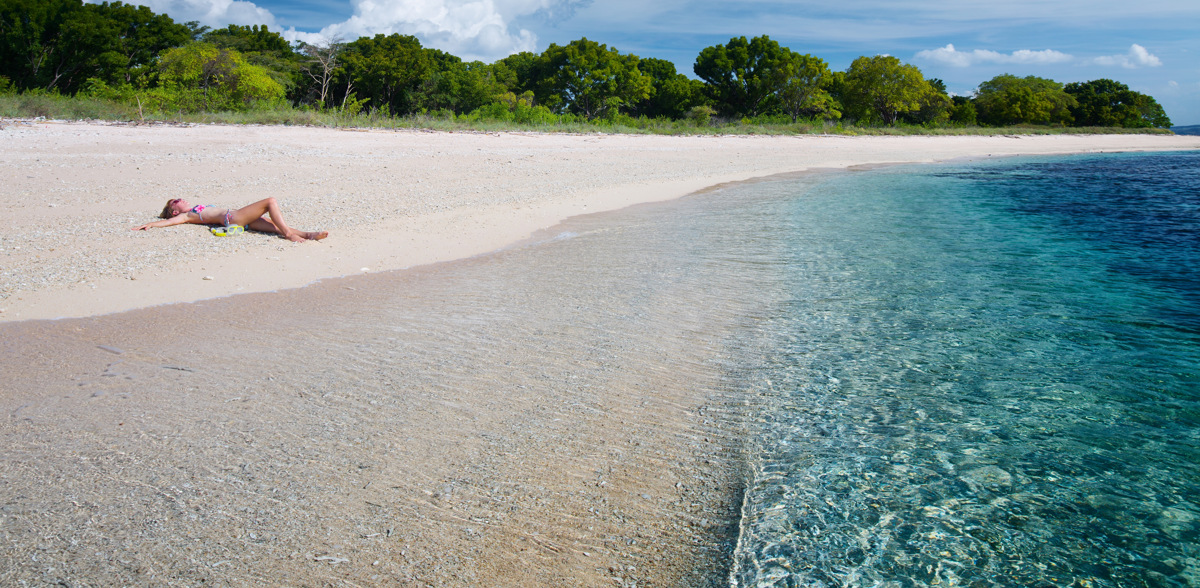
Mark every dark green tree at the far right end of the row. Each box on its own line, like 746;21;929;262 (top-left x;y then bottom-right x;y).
1063;79;1171;128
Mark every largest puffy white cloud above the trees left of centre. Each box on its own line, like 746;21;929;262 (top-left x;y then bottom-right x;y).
304;0;586;61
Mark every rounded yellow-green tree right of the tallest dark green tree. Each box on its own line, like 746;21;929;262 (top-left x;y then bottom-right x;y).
840;55;937;125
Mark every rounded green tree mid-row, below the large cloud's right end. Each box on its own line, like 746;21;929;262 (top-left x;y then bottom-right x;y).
536;38;652;119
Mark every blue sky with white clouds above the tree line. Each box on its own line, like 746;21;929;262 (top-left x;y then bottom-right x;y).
130;0;1200;125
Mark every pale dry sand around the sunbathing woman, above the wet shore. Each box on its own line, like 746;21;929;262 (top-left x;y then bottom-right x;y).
0;122;1200;322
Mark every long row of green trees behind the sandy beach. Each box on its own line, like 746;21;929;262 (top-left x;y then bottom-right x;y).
0;0;1171;128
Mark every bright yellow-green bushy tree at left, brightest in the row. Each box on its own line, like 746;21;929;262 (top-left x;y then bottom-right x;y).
158;42;284;112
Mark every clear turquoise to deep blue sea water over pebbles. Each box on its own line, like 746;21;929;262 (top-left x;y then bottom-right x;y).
724;152;1200;587
